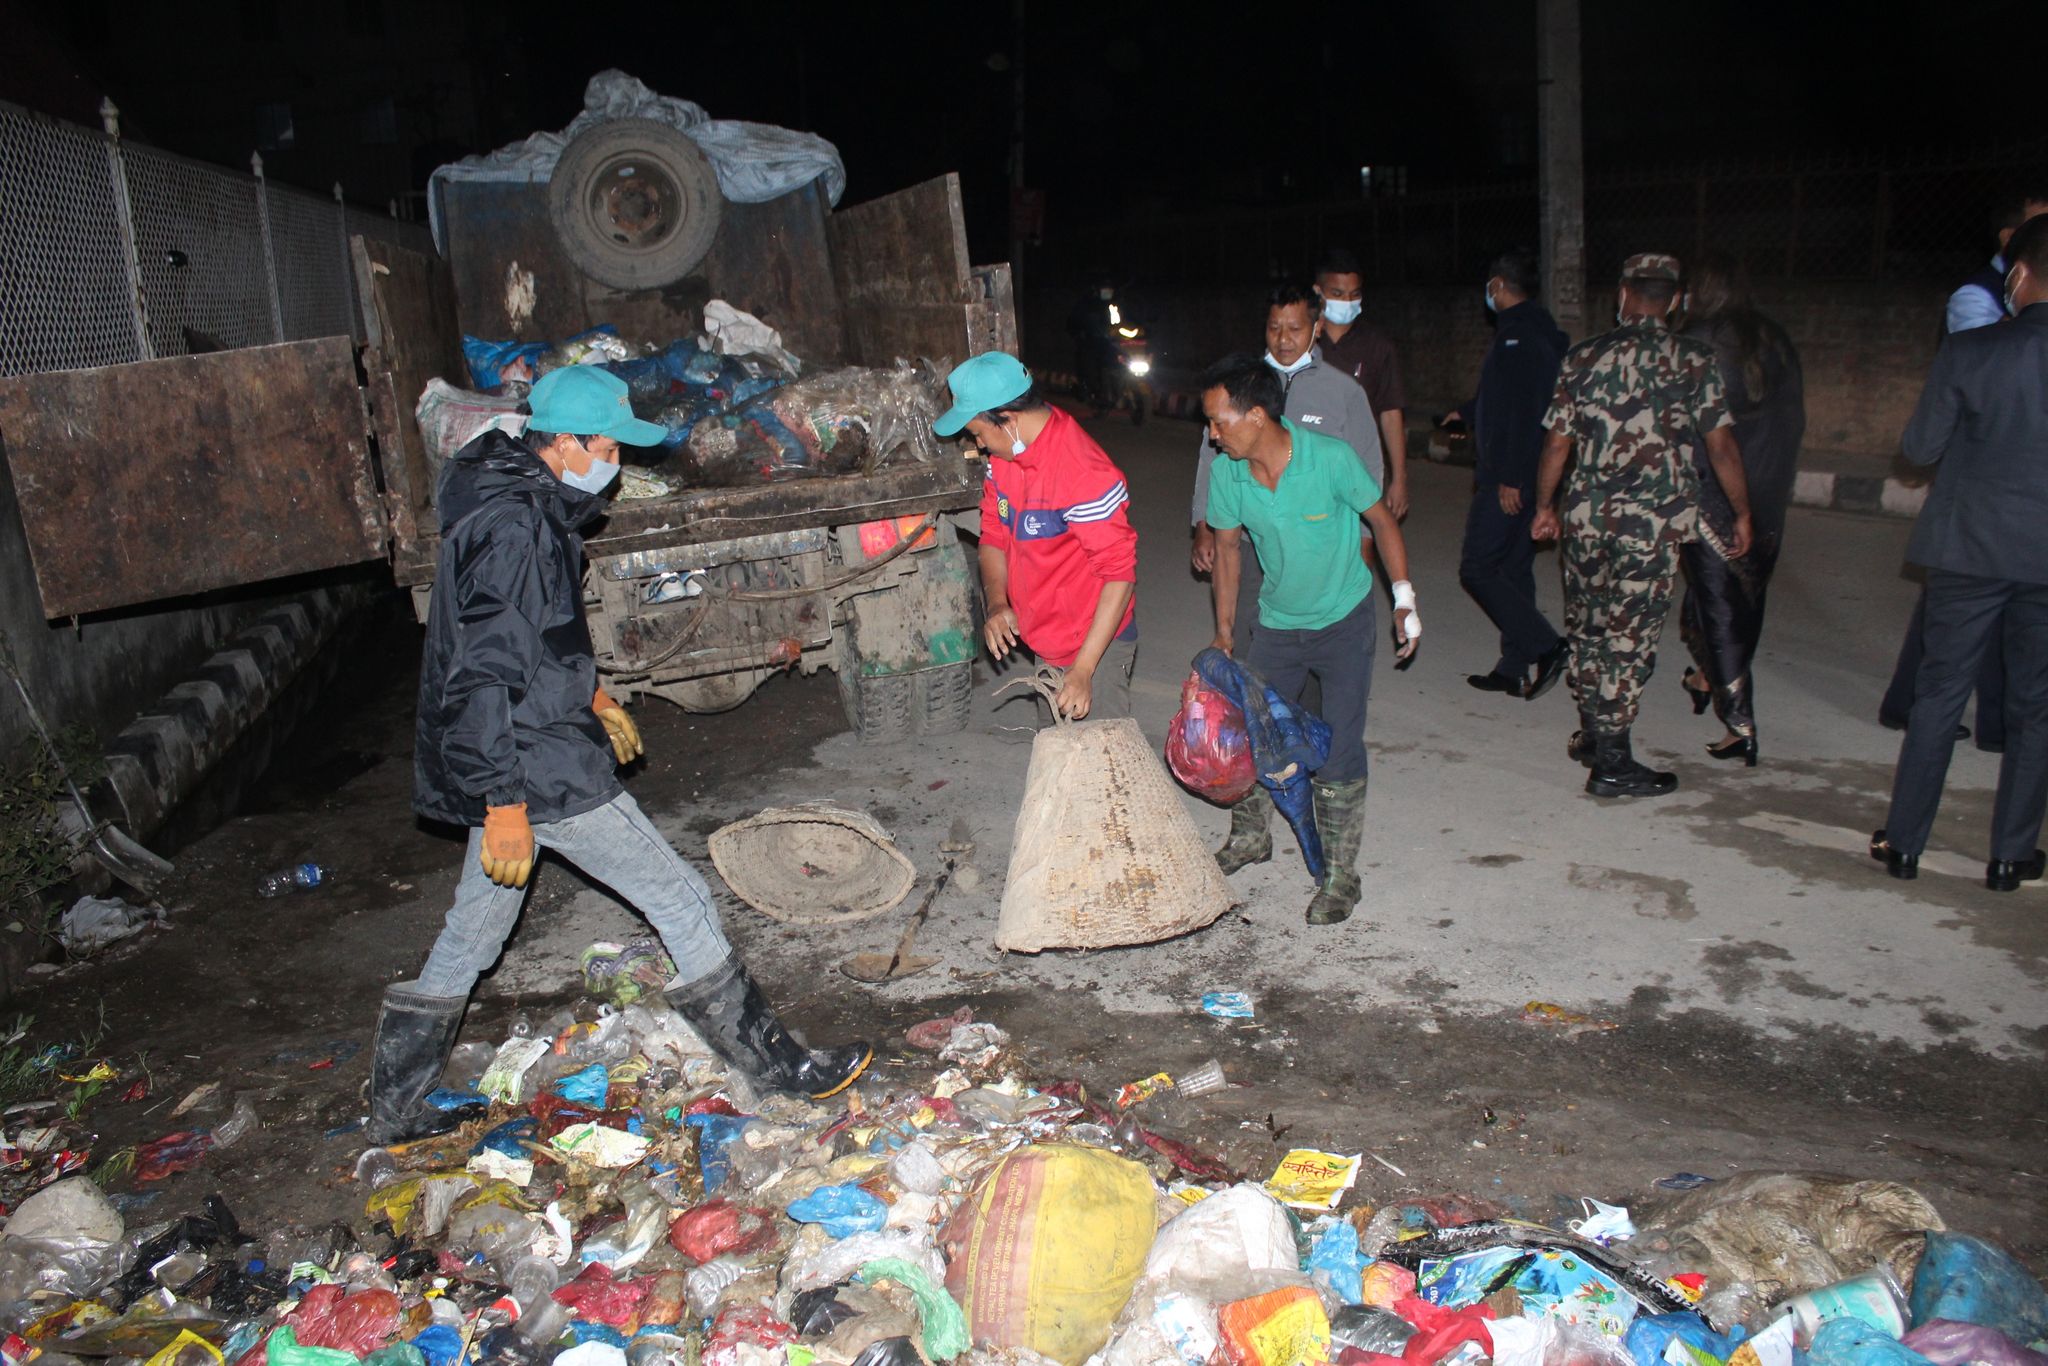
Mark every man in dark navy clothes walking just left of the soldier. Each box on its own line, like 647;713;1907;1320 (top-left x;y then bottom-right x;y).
1446;252;1567;700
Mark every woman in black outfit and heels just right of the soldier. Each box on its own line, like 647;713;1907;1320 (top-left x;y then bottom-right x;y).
1679;256;1806;768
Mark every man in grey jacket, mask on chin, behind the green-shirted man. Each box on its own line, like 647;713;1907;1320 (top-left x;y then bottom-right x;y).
1188;285;1386;639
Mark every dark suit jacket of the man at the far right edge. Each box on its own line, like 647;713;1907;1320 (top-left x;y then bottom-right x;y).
1905;303;2048;584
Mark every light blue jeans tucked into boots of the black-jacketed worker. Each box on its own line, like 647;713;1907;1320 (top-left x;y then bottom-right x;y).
414;793;733;997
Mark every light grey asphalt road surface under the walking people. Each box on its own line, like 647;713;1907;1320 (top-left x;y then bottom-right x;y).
598;411;2048;1057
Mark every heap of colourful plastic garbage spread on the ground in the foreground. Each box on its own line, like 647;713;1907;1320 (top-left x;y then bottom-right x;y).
0;958;2048;1366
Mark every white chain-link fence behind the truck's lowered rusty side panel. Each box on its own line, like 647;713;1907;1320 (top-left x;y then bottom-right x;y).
0;104;432;375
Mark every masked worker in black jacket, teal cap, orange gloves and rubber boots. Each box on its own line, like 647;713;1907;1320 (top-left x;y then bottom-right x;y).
367;365;872;1143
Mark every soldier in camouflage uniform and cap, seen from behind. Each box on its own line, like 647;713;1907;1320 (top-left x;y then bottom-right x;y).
1530;252;1749;797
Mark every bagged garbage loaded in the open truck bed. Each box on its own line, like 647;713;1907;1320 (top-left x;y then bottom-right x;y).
428;299;942;496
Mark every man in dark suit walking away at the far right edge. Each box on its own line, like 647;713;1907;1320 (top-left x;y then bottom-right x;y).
1870;215;2048;891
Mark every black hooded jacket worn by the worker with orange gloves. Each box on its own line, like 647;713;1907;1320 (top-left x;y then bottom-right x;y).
412;432;621;825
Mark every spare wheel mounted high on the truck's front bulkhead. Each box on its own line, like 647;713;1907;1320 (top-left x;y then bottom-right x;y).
547;119;725;289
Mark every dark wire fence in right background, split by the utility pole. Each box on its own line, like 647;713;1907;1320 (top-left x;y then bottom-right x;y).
1028;141;2048;287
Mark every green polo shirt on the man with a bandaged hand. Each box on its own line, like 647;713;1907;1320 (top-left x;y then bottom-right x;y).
1208;420;1380;631
